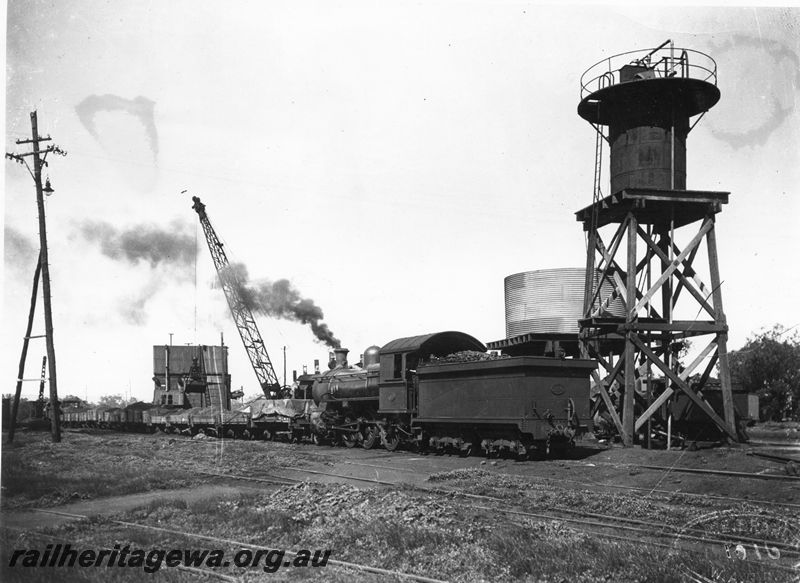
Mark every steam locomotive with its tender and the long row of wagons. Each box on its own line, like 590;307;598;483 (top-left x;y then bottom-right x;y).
57;331;596;457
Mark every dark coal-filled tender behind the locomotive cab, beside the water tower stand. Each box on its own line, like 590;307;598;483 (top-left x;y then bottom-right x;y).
414;356;595;456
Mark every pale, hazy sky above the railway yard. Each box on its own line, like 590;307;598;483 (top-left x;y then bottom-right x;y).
0;0;800;400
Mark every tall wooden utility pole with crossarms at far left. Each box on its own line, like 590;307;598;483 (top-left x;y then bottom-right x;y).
6;111;66;443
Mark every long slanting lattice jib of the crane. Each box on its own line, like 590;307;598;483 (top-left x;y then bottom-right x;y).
192;196;280;398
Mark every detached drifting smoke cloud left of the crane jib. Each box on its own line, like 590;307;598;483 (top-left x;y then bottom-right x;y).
80;221;196;267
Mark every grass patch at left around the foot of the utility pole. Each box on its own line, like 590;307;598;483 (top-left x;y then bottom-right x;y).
0;431;327;510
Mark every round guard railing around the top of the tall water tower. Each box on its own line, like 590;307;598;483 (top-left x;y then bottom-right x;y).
581;41;717;99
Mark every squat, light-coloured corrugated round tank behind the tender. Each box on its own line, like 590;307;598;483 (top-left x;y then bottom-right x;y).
505;267;625;338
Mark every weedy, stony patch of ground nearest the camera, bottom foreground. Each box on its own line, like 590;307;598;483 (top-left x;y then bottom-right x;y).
0;485;788;583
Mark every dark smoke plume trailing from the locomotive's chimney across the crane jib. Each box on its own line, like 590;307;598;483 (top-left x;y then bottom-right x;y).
222;263;342;348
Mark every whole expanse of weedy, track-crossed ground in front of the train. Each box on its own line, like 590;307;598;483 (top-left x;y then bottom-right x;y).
0;426;800;583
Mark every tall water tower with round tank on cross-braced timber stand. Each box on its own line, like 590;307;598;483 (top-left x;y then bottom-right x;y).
576;41;739;445
